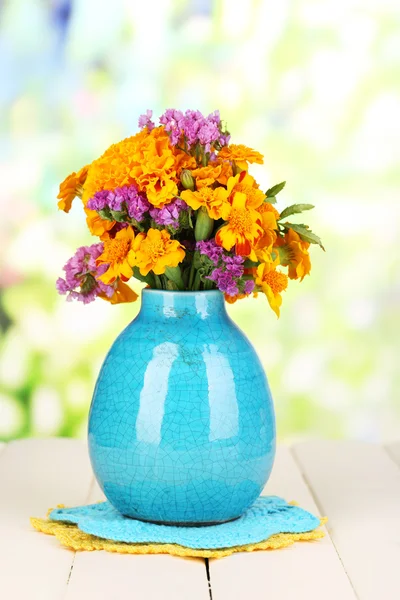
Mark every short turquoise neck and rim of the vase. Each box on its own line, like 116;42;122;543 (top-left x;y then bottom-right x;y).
140;289;226;319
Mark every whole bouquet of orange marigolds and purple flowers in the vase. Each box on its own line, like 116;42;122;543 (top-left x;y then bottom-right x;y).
57;109;322;316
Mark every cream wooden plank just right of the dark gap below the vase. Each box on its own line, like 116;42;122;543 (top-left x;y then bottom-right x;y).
210;447;355;600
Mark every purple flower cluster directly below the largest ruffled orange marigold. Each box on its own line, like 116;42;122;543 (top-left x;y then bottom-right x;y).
87;184;150;222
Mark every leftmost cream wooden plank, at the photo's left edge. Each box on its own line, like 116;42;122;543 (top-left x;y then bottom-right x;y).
0;439;92;600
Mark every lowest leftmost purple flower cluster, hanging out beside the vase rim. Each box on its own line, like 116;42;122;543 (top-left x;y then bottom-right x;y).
56;243;115;304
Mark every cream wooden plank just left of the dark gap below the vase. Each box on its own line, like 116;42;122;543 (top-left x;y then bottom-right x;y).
66;483;209;600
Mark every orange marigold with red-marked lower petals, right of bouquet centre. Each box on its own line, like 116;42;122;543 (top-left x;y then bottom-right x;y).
215;192;263;260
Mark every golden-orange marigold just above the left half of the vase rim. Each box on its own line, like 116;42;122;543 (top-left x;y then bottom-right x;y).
133;228;185;276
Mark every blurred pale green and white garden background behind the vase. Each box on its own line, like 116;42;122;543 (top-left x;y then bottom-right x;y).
0;0;400;440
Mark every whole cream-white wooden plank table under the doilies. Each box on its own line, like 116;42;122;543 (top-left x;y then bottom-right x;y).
0;439;400;600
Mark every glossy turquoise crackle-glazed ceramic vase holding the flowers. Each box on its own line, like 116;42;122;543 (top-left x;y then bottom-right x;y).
89;289;275;525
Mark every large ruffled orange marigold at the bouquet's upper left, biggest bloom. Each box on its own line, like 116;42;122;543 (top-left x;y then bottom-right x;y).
82;127;178;206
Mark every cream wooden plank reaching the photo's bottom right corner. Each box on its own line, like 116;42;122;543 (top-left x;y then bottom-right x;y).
294;441;400;600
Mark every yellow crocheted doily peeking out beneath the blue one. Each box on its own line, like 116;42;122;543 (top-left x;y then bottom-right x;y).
31;510;327;558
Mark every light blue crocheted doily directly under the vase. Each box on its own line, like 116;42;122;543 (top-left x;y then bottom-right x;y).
50;496;320;549
